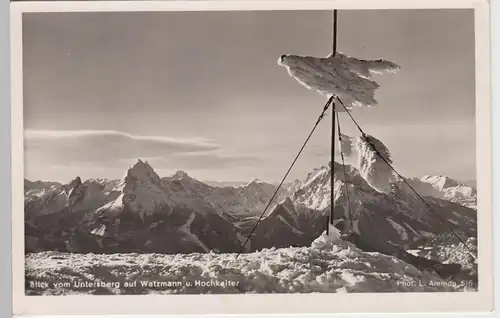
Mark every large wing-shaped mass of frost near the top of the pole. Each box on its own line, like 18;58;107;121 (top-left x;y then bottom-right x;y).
278;52;400;111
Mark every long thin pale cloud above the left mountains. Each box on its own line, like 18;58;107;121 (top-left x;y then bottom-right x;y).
24;130;220;164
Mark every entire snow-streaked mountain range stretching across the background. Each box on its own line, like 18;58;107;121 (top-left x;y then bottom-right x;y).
24;160;477;254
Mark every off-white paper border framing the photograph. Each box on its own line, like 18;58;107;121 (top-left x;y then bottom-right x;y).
10;0;493;315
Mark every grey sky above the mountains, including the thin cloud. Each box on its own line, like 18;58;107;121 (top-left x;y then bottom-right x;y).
23;9;476;182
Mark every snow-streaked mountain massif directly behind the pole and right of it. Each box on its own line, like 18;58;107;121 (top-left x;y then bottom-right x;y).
250;162;477;254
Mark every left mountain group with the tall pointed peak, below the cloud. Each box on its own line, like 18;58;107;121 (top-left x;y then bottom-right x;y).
25;160;290;253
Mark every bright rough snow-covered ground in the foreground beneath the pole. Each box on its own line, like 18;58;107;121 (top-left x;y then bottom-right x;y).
26;236;474;295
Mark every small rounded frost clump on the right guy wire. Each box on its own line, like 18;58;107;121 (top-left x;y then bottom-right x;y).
356;135;396;193
